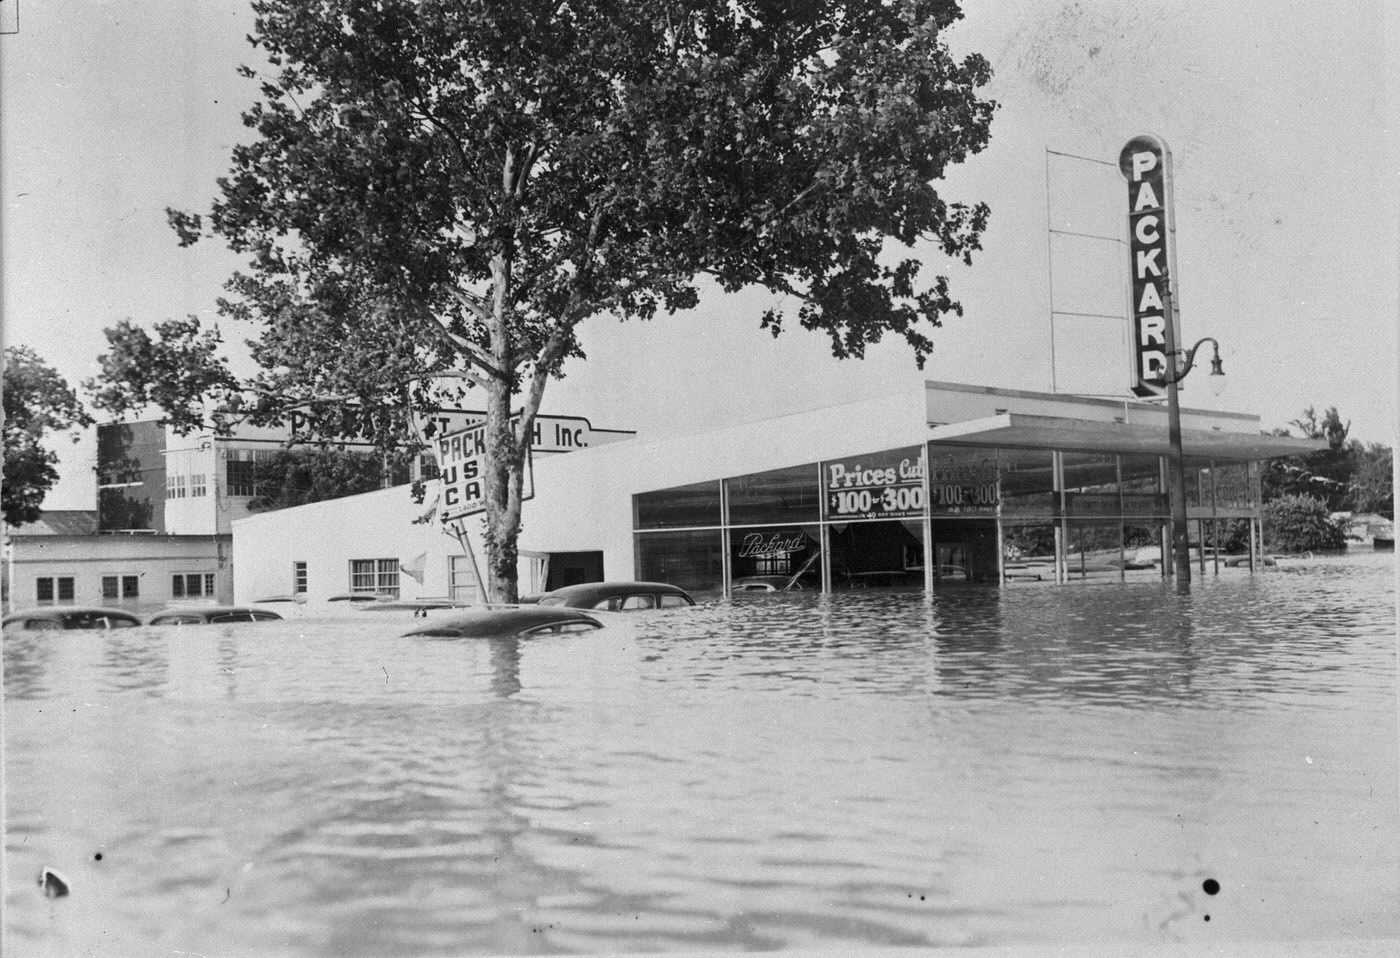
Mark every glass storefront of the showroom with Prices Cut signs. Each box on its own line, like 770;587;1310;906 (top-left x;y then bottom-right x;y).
633;443;1259;592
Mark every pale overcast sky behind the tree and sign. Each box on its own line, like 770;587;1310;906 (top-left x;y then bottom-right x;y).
0;0;1400;508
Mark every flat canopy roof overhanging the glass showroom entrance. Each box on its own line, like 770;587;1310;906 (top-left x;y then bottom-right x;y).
928;413;1327;459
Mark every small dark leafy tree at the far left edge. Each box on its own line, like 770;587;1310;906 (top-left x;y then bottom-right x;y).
0;346;92;525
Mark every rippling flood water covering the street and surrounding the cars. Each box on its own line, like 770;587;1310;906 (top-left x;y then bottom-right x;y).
4;555;1400;955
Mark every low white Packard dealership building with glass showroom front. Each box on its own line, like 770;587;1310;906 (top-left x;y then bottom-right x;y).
232;382;1320;602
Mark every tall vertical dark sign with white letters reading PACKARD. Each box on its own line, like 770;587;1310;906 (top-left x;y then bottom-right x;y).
1119;133;1176;396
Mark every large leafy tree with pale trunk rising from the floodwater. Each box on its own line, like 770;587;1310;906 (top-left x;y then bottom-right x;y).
95;0;994;601
